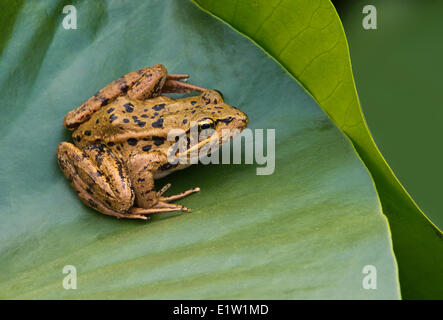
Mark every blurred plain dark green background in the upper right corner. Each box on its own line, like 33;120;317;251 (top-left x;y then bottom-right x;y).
332;0;443;229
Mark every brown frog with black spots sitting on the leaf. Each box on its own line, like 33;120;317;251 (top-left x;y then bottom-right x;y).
57;64;249;220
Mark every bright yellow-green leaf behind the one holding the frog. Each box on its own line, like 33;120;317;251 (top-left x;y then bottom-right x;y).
194;0;443;299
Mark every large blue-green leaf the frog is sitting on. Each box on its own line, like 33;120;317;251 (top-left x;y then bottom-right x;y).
0;0;399;299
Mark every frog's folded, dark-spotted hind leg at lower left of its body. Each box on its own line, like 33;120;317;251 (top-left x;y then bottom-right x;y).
57;142;146;219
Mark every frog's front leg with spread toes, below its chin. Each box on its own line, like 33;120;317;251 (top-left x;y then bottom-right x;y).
128;152;200;214
